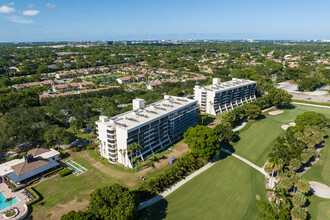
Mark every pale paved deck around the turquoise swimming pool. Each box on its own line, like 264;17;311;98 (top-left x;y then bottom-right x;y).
0;183;30;220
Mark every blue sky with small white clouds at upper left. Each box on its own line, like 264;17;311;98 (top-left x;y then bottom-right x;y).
0;0;330;42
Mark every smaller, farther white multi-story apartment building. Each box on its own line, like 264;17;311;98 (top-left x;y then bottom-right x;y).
194;78;257;115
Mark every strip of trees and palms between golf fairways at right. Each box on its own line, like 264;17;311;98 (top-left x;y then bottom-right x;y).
258;112;329;219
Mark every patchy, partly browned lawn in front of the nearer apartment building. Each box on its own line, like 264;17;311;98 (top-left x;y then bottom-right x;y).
32;150;162;219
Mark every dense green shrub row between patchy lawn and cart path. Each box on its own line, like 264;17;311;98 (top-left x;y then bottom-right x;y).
135;152;204;201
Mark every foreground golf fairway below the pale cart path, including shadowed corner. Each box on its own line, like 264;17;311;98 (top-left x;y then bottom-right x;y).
141;157;266;219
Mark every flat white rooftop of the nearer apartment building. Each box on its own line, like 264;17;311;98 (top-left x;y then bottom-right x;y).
97;96;197;130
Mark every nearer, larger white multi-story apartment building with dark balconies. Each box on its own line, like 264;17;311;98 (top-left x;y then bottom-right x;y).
96;95;198;167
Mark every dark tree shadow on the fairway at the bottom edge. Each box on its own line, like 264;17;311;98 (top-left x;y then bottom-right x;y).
138;199;168;220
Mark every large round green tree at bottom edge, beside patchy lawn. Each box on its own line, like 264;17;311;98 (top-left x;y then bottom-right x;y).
61;183;138;220
